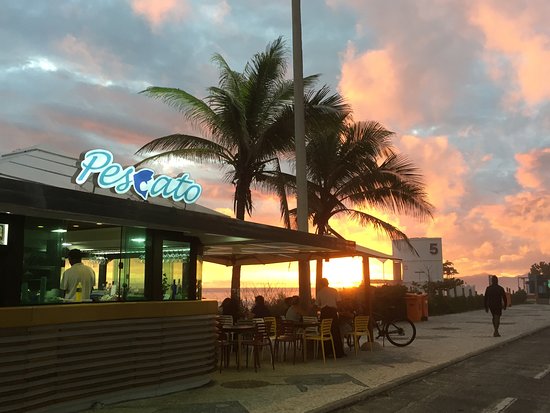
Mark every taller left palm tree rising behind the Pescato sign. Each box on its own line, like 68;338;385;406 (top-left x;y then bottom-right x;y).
137;37;347;300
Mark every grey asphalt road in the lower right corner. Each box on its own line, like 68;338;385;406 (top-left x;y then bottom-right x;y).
335;328;550;413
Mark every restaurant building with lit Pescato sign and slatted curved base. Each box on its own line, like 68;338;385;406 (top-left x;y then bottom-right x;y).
0;148;391;412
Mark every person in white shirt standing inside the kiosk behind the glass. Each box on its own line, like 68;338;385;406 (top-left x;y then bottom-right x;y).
60;249;95;301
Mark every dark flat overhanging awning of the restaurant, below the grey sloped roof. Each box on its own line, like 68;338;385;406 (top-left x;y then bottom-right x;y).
0;178;366;265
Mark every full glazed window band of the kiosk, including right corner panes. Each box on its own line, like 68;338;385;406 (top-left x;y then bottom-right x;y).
17;217;198;305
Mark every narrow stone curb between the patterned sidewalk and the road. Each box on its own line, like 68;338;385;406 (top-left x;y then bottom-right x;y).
305;325;550;413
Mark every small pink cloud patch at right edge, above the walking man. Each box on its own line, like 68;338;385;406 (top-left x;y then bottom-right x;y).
515;148;550;191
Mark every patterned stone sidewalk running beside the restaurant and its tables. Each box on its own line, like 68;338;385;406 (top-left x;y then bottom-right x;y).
81;304;550;413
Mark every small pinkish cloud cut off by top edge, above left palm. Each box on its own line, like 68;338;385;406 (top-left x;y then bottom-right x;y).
131;0;191;30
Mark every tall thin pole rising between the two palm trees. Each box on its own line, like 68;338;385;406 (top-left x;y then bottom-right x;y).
292;0;311;305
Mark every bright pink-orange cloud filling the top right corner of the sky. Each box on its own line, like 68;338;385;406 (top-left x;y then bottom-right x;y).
470;1;550;110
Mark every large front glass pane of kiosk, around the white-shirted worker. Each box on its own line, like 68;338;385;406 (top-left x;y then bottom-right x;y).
21;217;148;305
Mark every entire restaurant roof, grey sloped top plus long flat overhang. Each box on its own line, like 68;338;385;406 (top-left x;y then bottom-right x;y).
0;148;395;265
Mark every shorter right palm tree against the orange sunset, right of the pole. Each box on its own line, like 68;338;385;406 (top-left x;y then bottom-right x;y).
276;116;433;288
